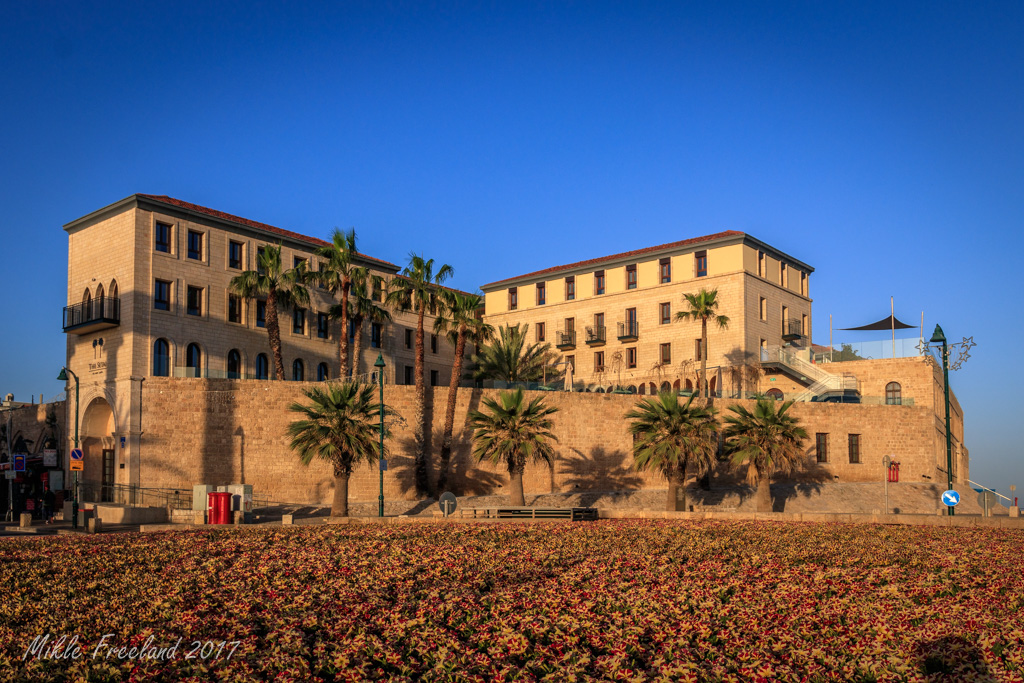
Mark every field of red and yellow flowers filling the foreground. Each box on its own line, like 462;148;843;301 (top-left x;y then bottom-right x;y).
0;521;1024;682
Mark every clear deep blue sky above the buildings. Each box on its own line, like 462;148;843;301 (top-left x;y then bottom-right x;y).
0;2;1024;497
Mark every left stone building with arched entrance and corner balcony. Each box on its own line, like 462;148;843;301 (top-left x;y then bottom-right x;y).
63;195;453;499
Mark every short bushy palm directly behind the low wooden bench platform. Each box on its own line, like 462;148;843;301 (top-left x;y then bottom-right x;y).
469;389;558;506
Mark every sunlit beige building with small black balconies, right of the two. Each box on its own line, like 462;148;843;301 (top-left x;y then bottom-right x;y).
482;230;814;394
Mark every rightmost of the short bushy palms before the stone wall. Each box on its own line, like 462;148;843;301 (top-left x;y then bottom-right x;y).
725;398;807;512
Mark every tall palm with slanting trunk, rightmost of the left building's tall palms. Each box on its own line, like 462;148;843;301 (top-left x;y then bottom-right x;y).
434;290;495;492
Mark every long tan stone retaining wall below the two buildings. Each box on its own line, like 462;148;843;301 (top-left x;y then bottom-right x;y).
140;378;958;503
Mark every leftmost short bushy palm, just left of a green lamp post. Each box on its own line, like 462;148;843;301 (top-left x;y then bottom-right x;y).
288;382;394;517
